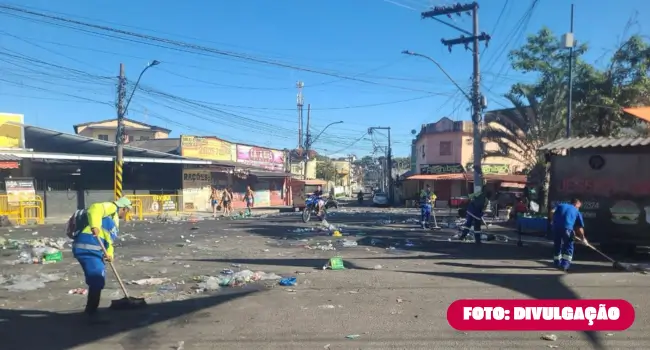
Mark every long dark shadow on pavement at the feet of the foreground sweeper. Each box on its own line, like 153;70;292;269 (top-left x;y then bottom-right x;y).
0;285;263;350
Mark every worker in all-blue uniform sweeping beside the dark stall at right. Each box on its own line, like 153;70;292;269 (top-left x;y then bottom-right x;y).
552;198;587;271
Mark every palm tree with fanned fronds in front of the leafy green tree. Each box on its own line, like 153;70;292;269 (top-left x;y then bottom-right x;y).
481;86;565;210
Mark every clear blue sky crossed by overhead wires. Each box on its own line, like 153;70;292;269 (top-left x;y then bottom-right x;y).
0;0;650;156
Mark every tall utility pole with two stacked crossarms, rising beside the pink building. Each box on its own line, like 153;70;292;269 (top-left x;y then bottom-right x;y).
422;2;491;192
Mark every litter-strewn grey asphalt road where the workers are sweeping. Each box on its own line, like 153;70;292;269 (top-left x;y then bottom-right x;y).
0;202;650;350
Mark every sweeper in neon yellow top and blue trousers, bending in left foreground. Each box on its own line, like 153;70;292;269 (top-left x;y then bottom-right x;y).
72;216;118;323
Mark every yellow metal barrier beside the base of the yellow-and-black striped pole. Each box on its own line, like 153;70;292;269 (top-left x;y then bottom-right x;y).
126;194;187;220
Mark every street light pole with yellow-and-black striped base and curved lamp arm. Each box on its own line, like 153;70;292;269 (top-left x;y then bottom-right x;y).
114;60;160;200
